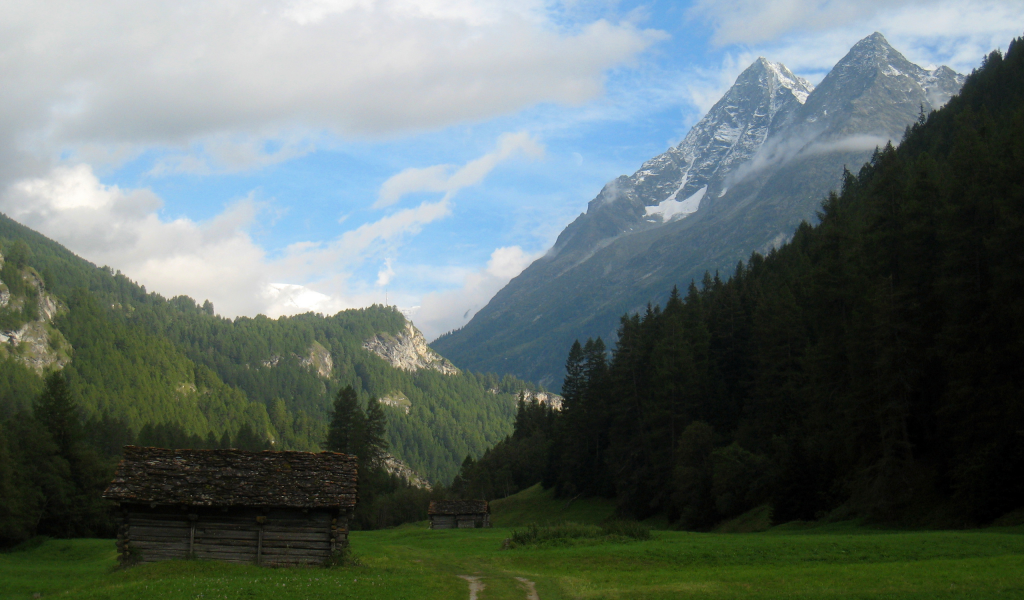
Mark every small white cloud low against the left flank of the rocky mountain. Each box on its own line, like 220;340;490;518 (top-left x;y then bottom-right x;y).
413;246;543;339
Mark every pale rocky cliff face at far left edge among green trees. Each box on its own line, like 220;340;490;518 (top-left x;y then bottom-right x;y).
0;256;72;375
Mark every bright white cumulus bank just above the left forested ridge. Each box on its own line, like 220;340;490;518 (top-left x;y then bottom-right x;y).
0;160;375;316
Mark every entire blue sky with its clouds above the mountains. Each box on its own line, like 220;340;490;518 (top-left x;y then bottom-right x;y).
0;0;1024;338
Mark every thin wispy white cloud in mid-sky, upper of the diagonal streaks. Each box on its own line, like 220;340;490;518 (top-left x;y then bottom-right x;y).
374;131;544;208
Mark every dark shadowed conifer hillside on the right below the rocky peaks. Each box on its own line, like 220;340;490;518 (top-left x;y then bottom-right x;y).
456;39;1024;528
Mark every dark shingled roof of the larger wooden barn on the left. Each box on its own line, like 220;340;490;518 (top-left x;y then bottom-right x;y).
103;445;356;508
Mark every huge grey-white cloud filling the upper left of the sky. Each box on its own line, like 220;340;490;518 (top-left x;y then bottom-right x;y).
0;0;663;184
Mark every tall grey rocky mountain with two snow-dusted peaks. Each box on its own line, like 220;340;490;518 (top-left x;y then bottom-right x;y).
431;33;964;387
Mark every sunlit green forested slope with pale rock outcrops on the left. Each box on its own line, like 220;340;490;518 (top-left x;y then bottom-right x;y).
0;215;534;483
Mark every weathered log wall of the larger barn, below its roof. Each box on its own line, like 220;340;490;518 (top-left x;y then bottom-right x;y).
118;505;348;566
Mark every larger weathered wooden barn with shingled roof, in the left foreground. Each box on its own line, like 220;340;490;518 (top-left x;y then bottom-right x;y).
103;445;356;566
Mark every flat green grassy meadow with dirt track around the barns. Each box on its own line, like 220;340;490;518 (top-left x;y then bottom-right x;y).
0;524;1024;600
